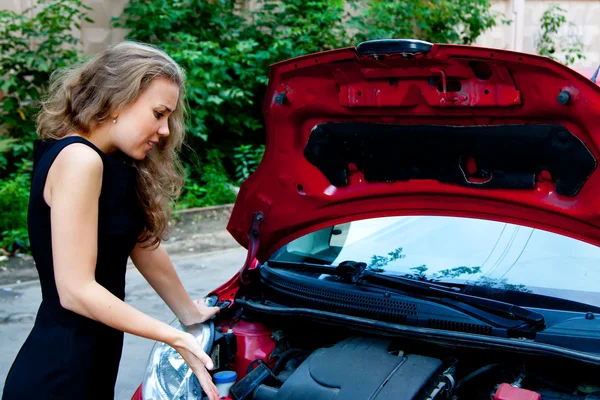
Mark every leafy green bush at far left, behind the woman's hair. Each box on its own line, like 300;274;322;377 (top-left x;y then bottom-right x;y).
0;0;91;166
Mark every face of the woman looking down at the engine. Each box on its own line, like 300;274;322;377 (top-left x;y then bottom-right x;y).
109;78;179;160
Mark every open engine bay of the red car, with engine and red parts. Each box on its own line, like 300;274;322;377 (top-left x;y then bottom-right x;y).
205;310;600;400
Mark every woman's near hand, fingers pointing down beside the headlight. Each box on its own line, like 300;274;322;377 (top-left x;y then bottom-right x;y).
170;332;219;400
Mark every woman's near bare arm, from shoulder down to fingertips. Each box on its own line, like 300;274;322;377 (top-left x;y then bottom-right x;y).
44;144;218;400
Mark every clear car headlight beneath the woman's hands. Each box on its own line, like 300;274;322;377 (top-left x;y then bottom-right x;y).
142;319;215;400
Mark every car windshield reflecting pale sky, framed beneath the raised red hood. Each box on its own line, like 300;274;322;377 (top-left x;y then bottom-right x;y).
270;216;600;306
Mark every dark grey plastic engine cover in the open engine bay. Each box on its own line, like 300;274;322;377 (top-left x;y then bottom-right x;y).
275;337;442;400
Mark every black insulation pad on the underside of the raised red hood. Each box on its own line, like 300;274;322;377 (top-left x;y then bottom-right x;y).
304;122;597;196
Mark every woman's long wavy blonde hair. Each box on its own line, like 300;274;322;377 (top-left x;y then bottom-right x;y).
37;41;185;246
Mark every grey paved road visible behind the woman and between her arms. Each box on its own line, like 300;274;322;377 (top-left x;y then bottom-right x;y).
0;247;246;400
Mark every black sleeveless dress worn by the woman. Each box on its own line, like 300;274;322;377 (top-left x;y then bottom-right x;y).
2;136;144;400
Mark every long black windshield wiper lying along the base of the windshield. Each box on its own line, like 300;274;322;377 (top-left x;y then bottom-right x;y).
269;261;546;331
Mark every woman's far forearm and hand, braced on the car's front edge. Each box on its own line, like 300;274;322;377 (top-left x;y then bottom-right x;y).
131;244;219;325
